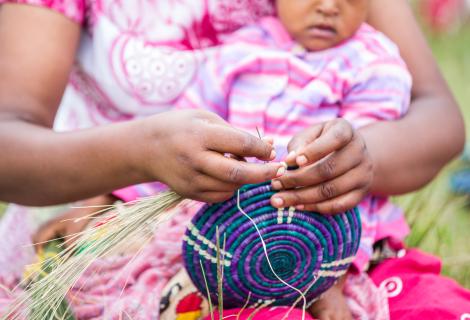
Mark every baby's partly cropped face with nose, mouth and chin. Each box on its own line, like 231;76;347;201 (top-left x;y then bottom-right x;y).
276;0;369;51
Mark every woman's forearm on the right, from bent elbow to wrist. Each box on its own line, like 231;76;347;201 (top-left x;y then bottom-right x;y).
360;95;465;195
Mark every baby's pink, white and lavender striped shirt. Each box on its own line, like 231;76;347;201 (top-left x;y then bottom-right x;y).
176;17;411;159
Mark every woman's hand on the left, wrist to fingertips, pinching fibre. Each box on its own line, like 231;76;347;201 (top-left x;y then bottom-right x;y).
135;110;285;202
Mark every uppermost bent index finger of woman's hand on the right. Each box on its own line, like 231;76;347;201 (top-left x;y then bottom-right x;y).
296;119;354;167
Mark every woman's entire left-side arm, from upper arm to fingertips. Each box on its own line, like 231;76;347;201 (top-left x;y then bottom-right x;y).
0;4;281;205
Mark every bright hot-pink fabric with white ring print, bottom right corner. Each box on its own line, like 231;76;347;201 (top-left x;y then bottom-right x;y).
370;249;470;320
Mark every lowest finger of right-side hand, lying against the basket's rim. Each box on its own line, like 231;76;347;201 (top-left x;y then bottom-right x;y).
273;166;370;207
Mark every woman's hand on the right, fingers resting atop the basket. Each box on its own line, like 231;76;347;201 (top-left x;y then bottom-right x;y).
271;119;374;213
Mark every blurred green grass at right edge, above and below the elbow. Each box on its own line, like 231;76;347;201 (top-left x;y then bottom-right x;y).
0;19;470;288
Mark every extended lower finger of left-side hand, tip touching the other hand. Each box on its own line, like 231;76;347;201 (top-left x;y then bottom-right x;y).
196;152;286;185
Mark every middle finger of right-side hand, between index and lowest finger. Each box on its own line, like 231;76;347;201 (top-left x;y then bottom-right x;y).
272;140;364;190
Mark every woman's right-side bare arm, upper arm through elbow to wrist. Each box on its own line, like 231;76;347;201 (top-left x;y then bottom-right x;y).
361;0;465;194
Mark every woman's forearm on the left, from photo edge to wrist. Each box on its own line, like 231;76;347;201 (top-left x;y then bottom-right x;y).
0;119;149;205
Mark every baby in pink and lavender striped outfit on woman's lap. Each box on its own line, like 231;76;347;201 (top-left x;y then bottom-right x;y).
29;0;411;319
